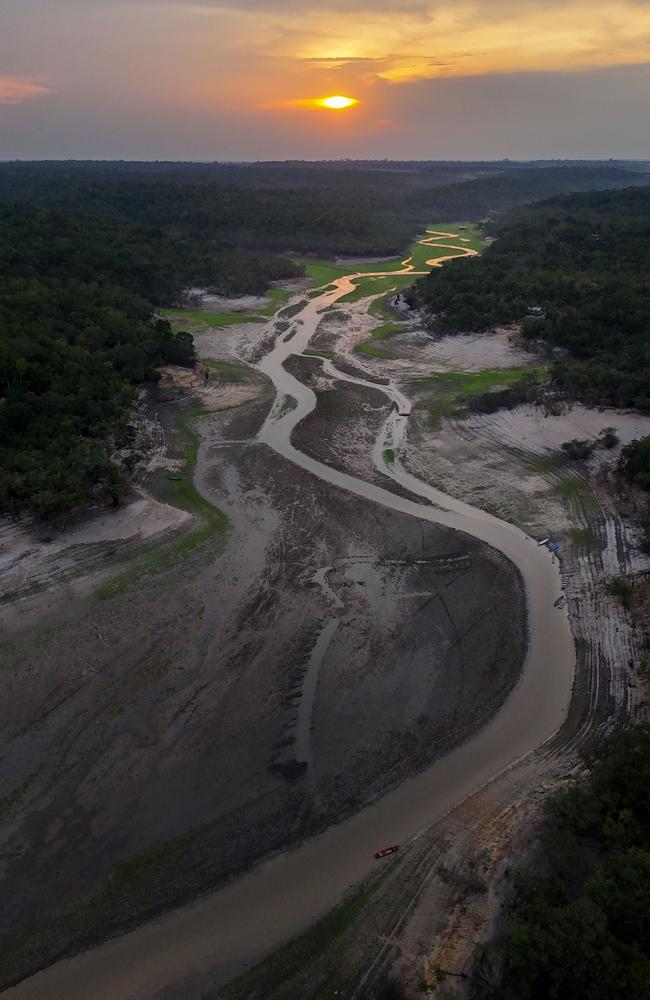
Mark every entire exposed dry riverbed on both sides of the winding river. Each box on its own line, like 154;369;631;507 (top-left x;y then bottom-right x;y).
0;258;650;1000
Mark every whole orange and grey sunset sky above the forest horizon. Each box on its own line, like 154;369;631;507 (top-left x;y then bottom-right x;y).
0;0;650;160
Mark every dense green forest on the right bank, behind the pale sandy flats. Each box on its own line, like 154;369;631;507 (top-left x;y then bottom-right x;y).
418;187;650;412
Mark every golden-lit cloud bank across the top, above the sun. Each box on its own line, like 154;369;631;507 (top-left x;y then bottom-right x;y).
157;0;650;83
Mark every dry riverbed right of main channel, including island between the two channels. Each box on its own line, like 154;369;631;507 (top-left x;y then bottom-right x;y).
210;310;650;1000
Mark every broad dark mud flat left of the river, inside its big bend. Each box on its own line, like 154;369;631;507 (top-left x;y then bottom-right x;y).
0;380;525;975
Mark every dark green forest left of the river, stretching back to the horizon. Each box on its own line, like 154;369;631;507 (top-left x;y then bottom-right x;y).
0;162;647;515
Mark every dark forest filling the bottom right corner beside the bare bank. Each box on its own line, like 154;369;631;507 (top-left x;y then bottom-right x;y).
483;725;650;1000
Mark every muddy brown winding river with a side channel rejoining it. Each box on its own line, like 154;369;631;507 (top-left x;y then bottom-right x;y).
5;262;575;1000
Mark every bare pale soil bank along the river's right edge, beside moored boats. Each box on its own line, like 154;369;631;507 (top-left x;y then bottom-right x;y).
225;338;650;1000
